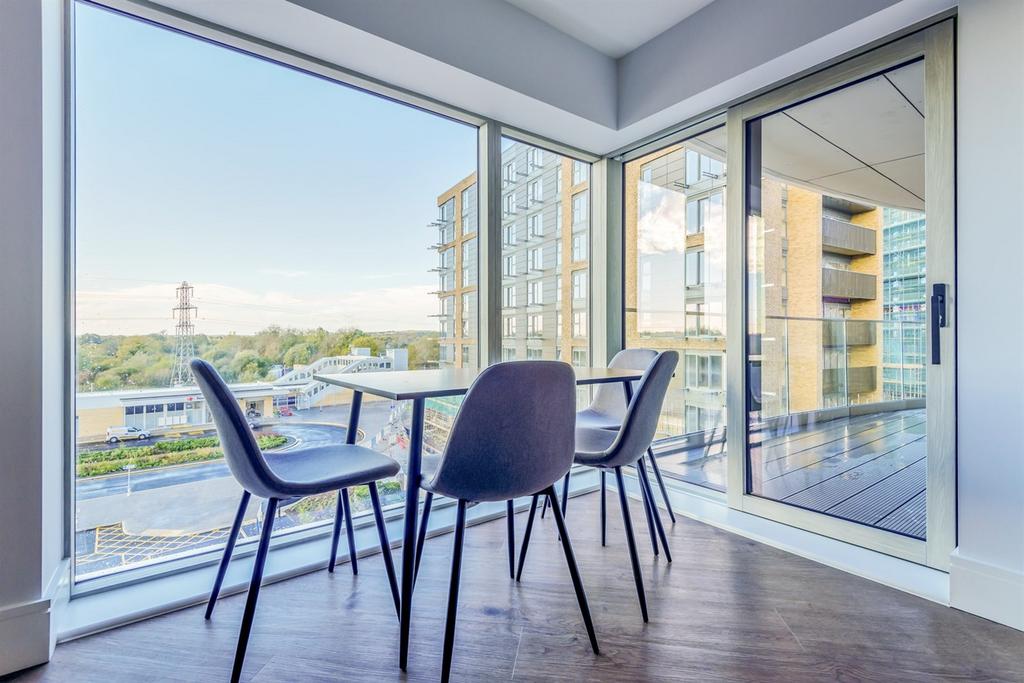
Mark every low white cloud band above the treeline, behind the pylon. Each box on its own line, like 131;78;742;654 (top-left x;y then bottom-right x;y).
76;283;438;335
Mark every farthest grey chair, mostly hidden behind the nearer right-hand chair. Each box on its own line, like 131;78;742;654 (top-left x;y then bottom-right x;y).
541;348;676;548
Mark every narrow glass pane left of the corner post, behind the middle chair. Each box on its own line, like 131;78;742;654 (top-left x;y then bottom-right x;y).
502;138;590;399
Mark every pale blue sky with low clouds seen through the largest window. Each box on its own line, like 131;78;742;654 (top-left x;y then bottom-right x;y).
75;4;476;334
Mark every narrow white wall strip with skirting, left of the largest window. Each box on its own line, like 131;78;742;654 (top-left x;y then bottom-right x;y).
0;0;67;674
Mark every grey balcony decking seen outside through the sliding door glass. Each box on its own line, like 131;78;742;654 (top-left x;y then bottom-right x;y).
658;410;927;539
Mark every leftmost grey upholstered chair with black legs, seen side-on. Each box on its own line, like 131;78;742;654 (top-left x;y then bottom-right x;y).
191;358;400;681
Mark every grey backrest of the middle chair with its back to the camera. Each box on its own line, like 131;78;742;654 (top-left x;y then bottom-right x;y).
430;360;575;501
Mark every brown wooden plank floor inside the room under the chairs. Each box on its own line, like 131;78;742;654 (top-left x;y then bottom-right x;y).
9;494;1024;683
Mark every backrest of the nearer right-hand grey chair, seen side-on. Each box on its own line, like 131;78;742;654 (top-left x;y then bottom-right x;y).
604;351;679;467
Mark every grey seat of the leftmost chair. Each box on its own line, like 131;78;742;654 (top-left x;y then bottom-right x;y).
263;444;401;498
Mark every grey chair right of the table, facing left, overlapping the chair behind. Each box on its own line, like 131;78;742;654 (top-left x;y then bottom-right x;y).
517;351;679;622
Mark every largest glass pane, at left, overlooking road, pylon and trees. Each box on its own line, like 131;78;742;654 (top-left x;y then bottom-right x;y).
74;4;477;581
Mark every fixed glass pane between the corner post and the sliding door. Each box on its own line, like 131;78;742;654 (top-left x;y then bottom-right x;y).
626;128;726;490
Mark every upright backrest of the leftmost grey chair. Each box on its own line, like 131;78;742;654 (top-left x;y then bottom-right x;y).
190;358;278;498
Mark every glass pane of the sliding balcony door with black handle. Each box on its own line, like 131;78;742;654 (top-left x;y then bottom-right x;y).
746;61;927;539
